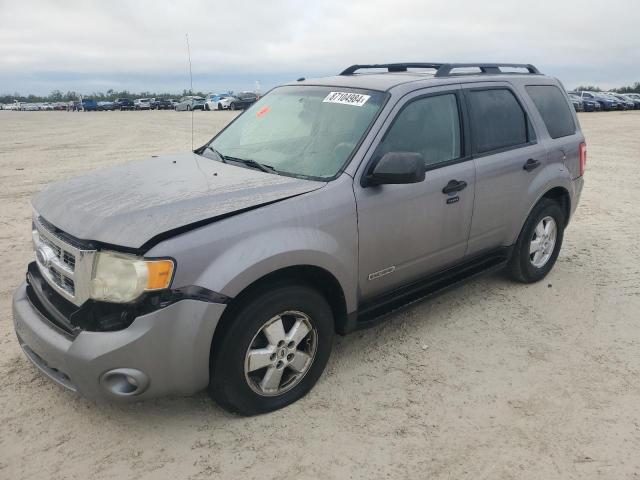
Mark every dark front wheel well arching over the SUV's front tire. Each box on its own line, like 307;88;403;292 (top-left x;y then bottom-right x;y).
214;265;347;338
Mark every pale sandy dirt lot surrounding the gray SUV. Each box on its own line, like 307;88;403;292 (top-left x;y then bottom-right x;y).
0;112;640;480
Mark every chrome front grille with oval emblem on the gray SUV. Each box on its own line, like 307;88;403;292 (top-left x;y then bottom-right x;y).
33;215;96;305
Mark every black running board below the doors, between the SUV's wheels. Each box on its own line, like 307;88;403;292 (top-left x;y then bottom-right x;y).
355;248;511;330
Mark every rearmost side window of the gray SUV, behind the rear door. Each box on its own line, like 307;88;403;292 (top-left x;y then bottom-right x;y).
525;85;576;138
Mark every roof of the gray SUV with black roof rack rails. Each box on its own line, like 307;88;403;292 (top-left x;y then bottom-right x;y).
289;63;541;91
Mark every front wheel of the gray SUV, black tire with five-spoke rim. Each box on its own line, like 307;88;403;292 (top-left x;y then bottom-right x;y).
209;283;334;415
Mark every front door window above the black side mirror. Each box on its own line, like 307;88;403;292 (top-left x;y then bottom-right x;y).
378;93;461;167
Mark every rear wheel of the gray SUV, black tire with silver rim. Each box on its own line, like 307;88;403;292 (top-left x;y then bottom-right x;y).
507;198;566;283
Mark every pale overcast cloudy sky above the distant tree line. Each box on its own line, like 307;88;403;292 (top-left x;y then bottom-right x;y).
0;0;640;94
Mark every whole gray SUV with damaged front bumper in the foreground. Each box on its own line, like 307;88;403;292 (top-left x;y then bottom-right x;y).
13;63;586;414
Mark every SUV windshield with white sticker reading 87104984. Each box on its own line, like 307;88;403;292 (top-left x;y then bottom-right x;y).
203;86;385;179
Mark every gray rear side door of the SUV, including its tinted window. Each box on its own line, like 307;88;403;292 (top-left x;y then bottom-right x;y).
463;82;547;257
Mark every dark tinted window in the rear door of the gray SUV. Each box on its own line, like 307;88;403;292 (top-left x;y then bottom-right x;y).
469;88;529;153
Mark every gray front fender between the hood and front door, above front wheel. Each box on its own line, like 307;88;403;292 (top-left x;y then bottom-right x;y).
147;175;358;312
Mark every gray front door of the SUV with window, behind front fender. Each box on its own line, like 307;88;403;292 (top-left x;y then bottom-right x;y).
354;86;475;300
